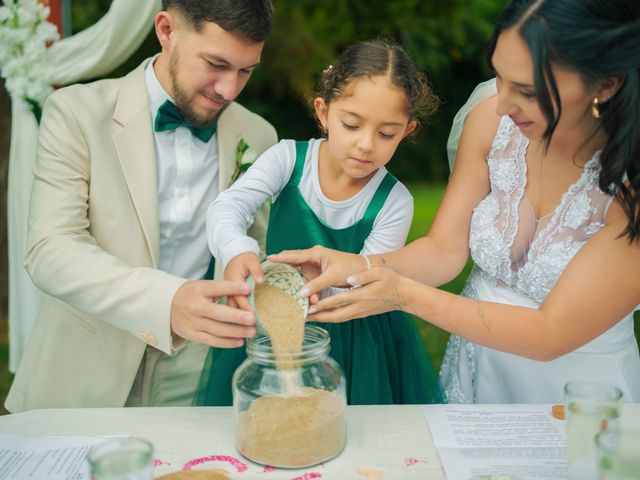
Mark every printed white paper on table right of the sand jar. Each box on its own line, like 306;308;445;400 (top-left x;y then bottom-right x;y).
424;405;567;480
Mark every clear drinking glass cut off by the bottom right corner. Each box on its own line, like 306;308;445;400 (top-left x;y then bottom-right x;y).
596;428;640;480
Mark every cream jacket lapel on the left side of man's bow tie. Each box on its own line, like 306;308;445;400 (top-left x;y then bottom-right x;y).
113;60;160;267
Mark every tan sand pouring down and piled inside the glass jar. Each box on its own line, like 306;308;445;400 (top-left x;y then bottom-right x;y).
236;284;346;468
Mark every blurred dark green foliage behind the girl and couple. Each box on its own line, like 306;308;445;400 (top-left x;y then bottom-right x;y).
72;0;506;181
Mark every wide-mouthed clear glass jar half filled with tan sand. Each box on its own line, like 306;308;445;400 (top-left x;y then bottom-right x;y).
233;325;347;468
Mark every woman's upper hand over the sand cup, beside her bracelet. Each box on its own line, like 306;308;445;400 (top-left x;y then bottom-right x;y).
269;245;367;297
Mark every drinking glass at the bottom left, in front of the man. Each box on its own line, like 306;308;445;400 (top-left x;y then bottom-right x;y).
88;437;153;480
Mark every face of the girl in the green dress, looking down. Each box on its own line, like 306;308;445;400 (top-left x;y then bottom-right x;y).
314;75;416;179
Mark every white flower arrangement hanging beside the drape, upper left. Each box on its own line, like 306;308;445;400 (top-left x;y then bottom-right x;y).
0;0;60;116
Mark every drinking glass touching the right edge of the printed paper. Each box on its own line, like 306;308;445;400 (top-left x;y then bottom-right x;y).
564;382;622;480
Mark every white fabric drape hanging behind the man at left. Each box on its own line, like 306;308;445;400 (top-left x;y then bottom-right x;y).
7;0;160;372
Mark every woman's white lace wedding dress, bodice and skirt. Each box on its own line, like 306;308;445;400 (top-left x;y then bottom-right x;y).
440;117;640;403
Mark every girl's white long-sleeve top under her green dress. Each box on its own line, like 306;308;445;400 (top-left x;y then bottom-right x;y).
206;139;413;268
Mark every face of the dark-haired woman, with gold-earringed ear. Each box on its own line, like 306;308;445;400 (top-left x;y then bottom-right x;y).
492;28;606;140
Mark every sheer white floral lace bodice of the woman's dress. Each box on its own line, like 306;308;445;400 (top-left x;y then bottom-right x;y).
465;116;612;303
